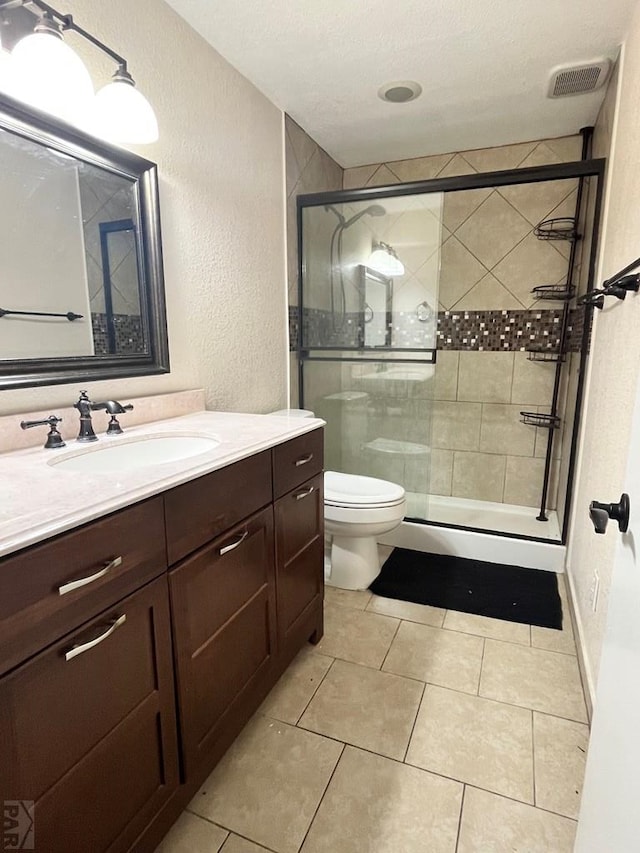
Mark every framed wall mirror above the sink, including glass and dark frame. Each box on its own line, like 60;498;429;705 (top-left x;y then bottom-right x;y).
0;90;169;388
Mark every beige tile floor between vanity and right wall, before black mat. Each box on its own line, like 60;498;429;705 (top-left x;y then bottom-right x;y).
157;576;589;853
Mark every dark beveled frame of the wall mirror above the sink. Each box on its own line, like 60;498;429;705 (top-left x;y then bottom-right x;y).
0;90;169;389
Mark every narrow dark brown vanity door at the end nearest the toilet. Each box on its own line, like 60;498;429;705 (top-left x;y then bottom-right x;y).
275;474;324;662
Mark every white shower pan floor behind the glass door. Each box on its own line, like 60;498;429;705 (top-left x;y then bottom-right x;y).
407;492;562;542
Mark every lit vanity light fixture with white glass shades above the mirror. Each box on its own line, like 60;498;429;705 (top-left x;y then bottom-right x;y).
0;0;158;144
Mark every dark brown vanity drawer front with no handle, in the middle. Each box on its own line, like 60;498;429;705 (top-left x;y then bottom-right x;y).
165;450;271;565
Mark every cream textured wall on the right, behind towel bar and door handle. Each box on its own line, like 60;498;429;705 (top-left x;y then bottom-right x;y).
567;45;640;688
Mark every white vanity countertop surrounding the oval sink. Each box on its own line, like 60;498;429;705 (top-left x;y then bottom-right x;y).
0;412;324;557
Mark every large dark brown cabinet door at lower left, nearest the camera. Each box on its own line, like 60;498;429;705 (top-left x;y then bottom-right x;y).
0;577;178;853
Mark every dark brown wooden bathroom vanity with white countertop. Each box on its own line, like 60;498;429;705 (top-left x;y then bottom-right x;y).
0;413;323;853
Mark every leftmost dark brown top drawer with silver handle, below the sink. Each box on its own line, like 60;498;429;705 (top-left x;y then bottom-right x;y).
0;498;167;673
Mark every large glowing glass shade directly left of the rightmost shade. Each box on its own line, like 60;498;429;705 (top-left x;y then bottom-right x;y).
6;32;93;124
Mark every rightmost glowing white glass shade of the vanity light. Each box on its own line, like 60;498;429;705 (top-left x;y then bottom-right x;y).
92;80;158;145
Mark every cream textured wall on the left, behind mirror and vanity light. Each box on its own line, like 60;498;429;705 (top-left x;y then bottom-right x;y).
0;0;287;413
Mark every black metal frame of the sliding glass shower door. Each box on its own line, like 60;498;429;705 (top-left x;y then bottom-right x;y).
295;158;607;545
